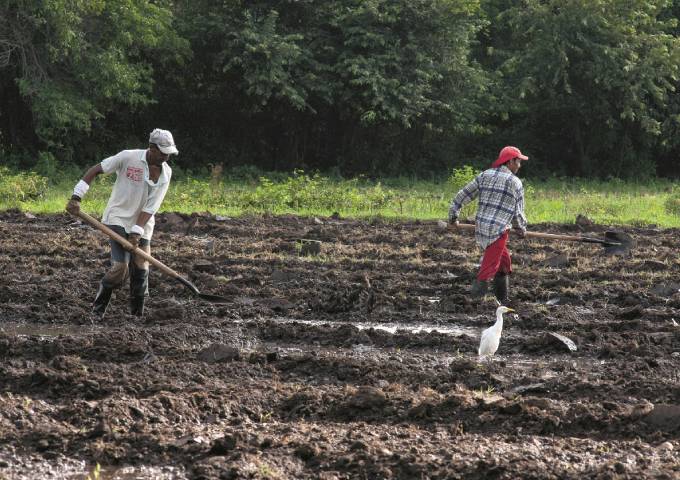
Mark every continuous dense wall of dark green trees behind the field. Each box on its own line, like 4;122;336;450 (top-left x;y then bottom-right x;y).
0;0;680;177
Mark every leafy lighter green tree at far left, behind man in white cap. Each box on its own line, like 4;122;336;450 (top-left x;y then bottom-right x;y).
0;0;188;161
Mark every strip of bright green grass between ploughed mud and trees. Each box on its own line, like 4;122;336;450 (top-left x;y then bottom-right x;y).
0;168;680;227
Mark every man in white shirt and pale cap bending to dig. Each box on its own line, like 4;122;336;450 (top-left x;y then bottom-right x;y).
66;128;179;316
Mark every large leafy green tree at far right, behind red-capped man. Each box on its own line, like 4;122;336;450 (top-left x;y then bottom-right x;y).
486;0;680;176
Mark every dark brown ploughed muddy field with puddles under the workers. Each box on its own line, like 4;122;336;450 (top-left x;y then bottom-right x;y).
0;212;680;479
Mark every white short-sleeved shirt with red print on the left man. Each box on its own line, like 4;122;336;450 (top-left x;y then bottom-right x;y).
101;150;172;239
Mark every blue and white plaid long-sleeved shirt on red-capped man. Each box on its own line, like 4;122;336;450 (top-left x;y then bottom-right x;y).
449;165;527;248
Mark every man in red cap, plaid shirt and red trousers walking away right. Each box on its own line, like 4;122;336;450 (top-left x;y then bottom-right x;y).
449;147;529;304
